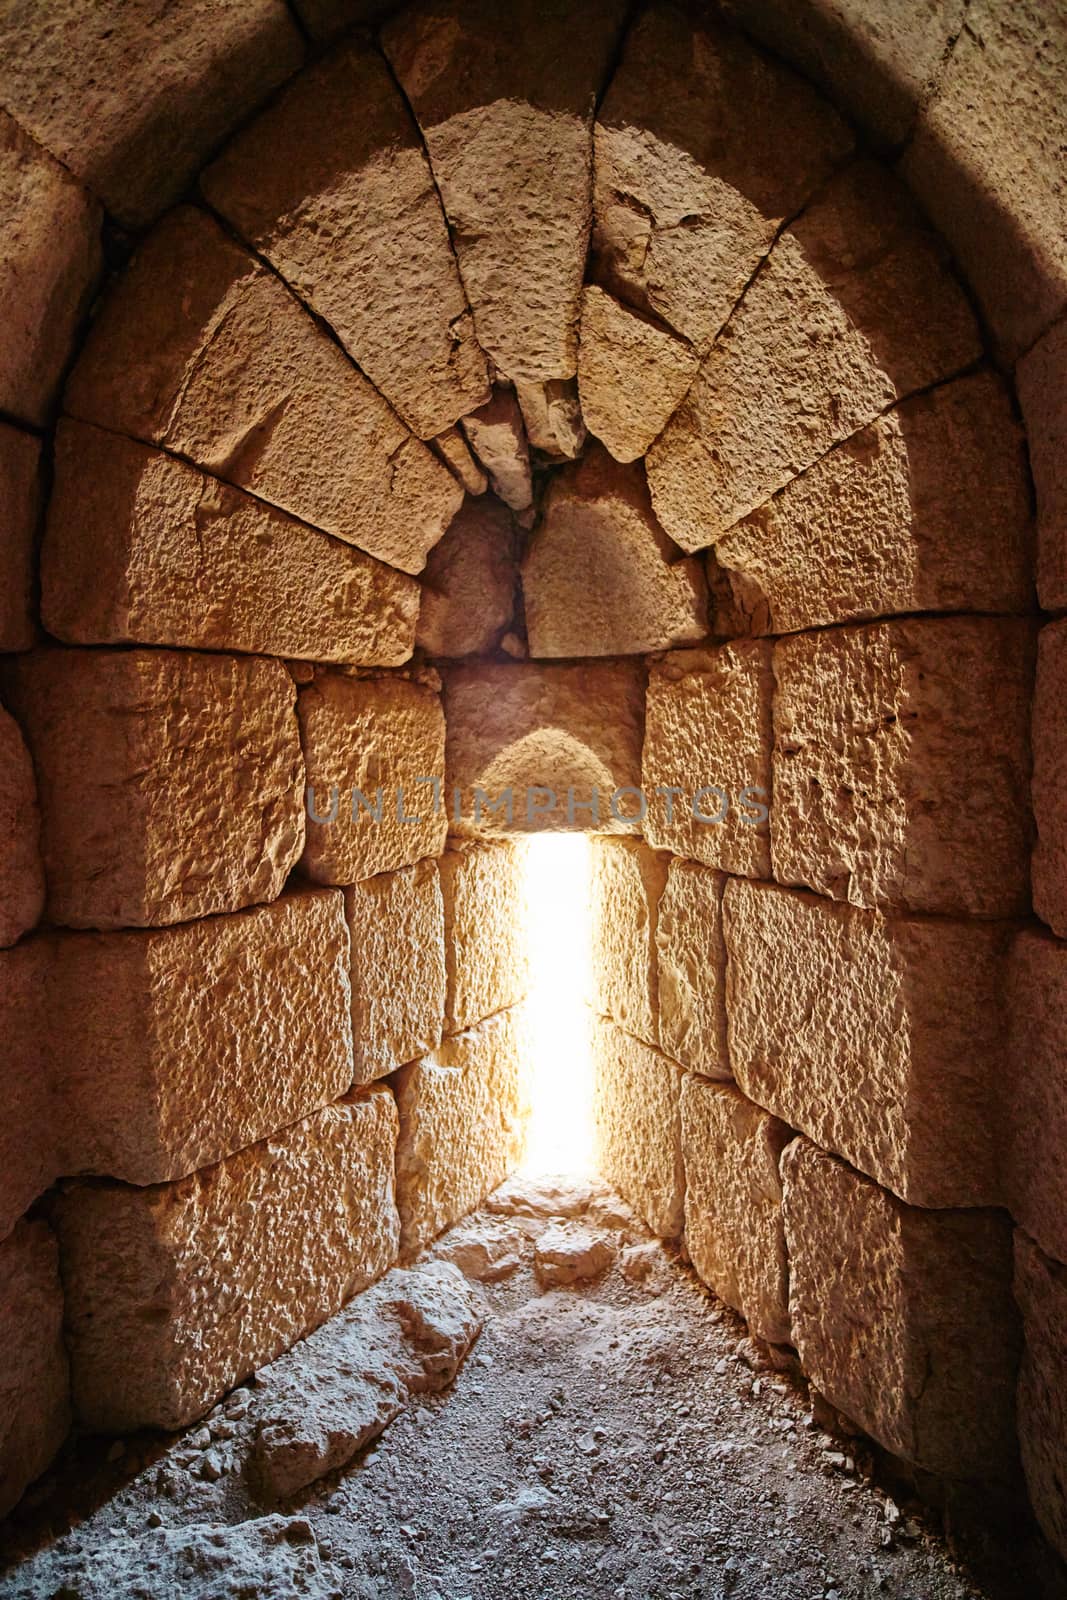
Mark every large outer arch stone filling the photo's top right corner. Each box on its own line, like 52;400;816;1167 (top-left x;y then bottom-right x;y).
902;0;1067;355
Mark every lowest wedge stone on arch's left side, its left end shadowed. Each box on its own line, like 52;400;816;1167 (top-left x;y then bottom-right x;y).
42;422;419;667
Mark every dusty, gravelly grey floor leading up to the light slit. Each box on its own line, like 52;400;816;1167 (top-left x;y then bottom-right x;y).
0;1177;1065;1600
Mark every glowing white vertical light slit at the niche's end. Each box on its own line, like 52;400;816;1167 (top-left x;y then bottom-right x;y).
522;834;593;1176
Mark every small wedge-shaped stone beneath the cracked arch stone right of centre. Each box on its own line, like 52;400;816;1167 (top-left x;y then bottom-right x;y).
577;283;699;461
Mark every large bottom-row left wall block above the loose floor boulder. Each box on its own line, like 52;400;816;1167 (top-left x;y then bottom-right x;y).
56;1086;398;1434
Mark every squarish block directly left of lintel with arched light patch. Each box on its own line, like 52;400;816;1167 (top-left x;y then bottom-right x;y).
298;674;448;883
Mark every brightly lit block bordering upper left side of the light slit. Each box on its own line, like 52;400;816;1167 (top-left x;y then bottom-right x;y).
438;842;530;1034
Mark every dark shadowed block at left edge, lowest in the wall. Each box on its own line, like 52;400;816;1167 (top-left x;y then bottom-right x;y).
0;1222;70;1515
